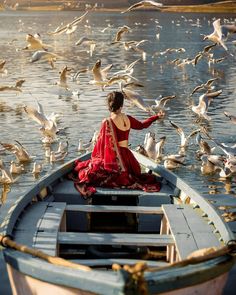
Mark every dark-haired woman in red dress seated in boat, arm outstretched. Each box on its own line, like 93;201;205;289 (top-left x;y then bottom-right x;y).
74;91;164;197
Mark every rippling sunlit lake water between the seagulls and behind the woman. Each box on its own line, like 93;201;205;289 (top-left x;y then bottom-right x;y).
0;11;236;206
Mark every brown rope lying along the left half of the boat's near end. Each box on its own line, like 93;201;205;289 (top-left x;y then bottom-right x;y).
0;235;91;271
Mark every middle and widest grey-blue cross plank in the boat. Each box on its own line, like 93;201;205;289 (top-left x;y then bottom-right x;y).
58;232;174;246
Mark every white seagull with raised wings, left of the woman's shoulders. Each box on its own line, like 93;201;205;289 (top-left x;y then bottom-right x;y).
23;102;58;142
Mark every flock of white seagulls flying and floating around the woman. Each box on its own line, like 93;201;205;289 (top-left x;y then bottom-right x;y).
0;1;236;204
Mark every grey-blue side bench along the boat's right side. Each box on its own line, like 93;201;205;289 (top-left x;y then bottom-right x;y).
161;204;221;262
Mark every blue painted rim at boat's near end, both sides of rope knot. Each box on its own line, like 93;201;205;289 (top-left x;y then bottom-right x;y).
4;249;234;295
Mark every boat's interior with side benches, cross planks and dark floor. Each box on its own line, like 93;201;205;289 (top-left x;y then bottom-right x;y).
13;169;221;270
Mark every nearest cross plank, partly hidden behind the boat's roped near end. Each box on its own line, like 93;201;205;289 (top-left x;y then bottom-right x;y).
70;258;169;267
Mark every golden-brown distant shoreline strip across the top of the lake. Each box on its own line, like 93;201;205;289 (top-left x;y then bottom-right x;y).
0;1;236;13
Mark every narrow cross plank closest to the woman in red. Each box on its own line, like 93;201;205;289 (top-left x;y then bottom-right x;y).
66;205;163;214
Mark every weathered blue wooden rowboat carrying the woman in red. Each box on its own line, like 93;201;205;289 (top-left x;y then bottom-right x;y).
0;151;235;295
